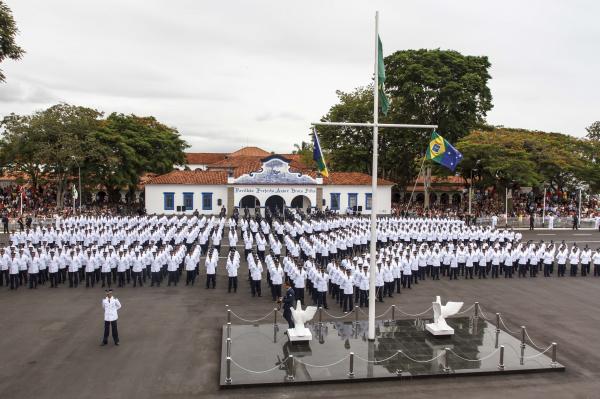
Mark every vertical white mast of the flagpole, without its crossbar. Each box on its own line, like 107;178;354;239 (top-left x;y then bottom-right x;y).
369;11;379;340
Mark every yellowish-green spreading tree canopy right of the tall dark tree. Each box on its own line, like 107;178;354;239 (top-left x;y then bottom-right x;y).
457;128;600;195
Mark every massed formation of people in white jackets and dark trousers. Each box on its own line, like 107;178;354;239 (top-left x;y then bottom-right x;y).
0;214;600;312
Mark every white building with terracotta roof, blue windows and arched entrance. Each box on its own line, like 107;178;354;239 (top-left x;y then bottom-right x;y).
145;147;394;214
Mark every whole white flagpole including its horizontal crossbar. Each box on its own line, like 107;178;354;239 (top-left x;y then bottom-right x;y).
311;11;437;340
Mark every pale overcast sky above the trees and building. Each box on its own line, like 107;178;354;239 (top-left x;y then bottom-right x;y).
0;0;600;153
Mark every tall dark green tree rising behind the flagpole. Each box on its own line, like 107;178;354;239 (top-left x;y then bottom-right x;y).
319;49;492;187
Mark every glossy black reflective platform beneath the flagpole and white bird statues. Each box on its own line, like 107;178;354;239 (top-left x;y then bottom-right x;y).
220;317;565;387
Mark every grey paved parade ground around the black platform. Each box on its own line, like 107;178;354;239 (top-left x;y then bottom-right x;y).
0;230;600;399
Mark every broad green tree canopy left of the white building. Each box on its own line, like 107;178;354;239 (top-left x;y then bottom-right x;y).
0;104;187;207
